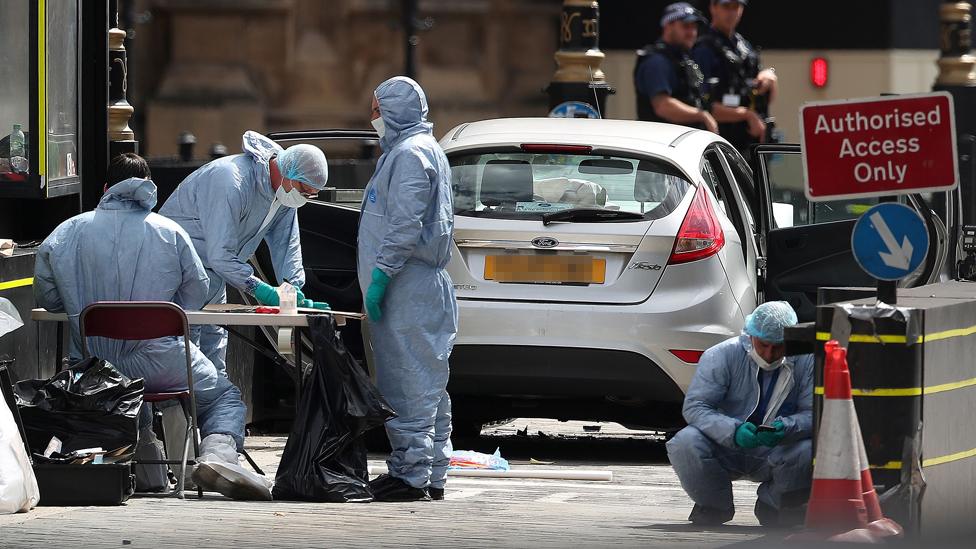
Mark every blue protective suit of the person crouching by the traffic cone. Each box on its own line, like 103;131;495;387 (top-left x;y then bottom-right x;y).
667;335;813;510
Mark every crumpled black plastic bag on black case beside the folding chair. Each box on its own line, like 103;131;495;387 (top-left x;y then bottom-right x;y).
14;358;144;455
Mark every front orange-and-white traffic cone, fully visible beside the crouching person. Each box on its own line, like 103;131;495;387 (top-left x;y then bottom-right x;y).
787;341;882;543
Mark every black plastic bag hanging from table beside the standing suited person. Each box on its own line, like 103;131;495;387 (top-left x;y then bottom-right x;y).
272;315;396;503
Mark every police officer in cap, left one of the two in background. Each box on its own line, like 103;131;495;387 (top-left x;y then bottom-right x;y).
634;2;718;133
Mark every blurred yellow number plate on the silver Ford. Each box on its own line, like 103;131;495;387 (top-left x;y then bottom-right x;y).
485;255;607;284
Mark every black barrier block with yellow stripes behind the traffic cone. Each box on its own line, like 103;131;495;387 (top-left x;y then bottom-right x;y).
794;282;976;539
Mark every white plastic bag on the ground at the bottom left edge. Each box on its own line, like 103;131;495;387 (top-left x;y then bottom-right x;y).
0;396;41;514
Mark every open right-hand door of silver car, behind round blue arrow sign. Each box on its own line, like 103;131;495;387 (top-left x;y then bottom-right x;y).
751;144;952;322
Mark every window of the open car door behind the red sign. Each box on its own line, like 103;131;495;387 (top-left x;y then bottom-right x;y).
759;151;878;229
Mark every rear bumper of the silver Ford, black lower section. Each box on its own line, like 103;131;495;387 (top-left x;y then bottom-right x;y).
451;256;742;401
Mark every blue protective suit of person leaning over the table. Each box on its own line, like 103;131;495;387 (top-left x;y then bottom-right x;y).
159;131;305;376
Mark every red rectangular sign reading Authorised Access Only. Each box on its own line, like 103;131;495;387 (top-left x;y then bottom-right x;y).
800;92;959;201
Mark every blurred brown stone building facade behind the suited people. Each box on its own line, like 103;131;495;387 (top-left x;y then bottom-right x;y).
130;0;562;158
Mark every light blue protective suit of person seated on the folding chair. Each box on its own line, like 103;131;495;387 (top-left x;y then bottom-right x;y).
34;178;245;447
